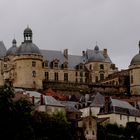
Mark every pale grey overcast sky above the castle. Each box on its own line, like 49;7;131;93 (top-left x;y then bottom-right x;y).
0;0;140;69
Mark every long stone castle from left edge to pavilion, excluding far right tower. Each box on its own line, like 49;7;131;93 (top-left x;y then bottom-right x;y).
0;27;117;89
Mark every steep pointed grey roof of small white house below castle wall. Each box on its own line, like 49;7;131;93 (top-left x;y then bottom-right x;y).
90;93;105;107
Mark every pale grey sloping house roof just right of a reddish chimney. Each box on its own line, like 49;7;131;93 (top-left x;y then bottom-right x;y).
44;96;65;107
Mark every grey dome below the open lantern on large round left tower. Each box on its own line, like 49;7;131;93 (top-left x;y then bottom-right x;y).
17;42;41;55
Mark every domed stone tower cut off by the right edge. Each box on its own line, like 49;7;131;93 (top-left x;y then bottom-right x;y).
129;41;140;95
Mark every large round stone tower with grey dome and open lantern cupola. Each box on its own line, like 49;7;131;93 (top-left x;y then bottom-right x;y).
13;27;43;89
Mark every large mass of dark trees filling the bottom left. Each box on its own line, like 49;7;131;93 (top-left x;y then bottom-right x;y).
0;85;75;140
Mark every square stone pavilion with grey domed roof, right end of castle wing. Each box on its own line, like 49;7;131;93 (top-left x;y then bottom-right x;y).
86;45;113;83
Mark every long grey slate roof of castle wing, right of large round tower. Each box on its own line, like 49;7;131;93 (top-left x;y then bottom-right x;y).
40;45;112;69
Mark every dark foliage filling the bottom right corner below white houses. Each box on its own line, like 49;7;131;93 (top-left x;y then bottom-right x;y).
97;122;140;140
